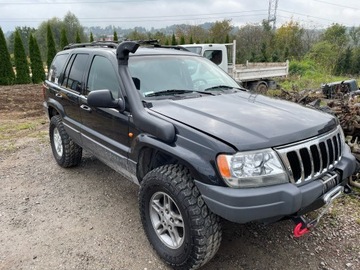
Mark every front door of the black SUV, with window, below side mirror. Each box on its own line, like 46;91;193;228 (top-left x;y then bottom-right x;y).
80;52;133;177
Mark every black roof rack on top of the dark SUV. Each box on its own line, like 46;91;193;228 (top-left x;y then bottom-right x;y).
64;39;189;51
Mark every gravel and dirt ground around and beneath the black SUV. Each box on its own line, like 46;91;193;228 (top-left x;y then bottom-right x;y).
0;85;360;270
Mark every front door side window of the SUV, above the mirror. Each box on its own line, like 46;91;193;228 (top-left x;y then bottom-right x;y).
85;55;120;99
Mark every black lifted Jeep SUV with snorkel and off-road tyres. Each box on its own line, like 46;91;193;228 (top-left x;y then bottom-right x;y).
43;41;356;269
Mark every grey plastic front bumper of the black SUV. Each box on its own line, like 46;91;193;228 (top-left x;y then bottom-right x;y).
195;147;356;223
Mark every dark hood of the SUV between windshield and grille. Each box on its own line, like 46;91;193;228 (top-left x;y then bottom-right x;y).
150;92;337;151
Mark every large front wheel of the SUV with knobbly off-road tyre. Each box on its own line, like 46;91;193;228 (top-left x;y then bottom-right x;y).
139;165;221;269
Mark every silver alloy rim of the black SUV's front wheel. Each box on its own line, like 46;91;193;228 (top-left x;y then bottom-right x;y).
149;192;185;249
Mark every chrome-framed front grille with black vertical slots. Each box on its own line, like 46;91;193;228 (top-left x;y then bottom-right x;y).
275;127;342;184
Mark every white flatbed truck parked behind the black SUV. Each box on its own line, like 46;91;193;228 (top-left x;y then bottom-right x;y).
182;40;289;93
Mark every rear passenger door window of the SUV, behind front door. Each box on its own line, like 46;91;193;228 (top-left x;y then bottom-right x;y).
62;54;89;92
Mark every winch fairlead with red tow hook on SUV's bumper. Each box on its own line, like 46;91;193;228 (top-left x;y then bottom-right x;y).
292;185;351;237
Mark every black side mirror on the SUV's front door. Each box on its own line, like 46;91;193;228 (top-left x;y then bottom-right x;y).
87;89;125;112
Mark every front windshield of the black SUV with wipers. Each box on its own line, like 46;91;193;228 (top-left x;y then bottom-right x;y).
129;55;239;97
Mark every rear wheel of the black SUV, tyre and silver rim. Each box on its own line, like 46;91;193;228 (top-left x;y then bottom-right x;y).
49;115;82;168
